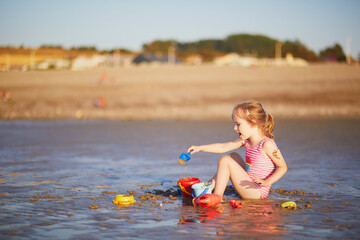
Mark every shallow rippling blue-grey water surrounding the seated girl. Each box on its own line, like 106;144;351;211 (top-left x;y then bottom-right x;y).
0;119;360;239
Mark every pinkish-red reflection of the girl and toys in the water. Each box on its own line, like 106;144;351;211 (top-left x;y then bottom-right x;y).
178;200;286;237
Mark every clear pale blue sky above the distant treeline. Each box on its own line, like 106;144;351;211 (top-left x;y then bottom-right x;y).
0;0;360;58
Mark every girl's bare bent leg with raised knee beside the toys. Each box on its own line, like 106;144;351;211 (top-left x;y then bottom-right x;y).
214;153;261;199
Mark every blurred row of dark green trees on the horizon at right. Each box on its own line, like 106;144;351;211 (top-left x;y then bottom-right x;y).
143;34;346;62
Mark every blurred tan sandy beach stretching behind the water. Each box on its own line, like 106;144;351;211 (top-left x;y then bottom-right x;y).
0;64;360;120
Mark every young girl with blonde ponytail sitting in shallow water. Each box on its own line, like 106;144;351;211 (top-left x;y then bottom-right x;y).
188;101;287;199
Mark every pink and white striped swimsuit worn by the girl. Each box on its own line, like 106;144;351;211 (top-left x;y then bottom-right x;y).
245;138;276;198
